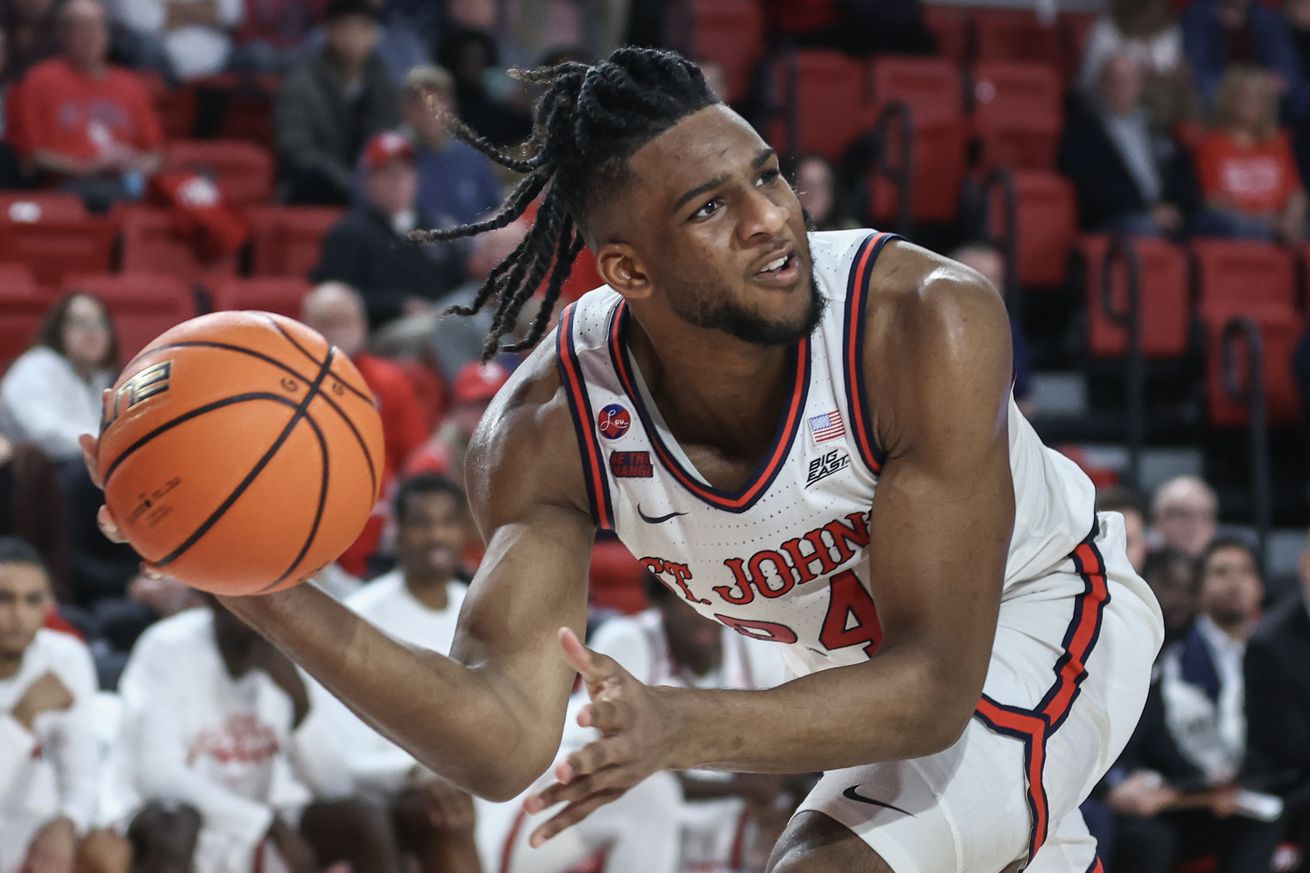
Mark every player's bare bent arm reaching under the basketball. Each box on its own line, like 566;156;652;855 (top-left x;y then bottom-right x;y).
91;351;595;800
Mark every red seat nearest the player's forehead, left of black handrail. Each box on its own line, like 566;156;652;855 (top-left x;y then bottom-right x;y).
769;50;870;161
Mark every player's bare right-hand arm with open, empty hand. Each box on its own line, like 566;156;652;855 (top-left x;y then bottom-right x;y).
529;244;1014;839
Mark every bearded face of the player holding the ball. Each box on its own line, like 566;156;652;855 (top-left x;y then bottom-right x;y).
621;105;823;345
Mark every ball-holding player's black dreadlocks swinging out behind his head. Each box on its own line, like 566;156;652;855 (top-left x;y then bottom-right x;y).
413;49;718;360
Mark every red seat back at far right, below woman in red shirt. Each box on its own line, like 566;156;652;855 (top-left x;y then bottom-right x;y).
1191;240;1297;312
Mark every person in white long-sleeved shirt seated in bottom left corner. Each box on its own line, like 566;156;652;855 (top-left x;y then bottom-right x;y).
0;536;131;873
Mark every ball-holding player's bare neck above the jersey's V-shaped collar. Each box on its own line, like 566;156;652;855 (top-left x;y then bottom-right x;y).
627;319;795;443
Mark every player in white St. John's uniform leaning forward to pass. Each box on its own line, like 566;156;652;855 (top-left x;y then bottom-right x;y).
88;49;1161;873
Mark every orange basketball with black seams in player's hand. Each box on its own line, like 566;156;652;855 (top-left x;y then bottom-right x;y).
97;312;383;594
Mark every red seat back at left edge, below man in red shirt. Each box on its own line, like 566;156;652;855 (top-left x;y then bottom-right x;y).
0;212;115;287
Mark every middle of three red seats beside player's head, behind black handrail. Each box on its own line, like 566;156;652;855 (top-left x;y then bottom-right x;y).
869;58;968;222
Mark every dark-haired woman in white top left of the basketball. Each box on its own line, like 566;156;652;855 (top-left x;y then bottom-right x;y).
0;292;118;464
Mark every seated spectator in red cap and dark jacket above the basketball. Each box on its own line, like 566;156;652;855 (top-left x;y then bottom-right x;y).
313;132;464;328
